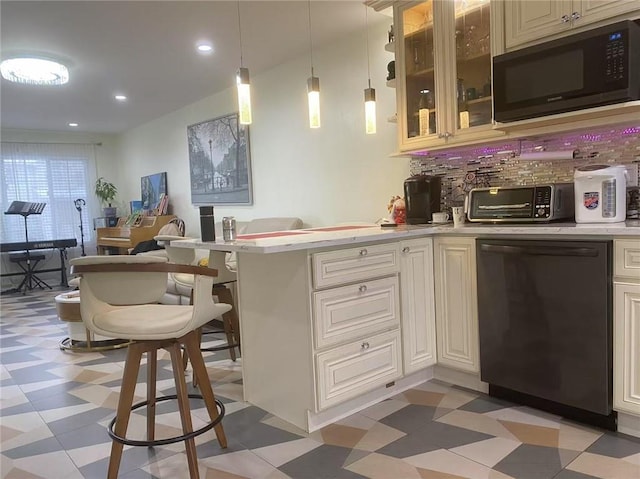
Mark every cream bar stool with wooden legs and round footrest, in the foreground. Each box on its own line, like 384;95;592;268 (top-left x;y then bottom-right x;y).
71;255;231;479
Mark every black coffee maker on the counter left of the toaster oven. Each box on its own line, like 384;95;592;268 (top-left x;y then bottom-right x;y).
404;175;442;225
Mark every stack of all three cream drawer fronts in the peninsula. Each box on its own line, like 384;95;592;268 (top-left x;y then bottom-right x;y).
311;246;402;411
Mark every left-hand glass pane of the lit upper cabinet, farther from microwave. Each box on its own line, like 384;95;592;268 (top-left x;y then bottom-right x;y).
401;0;437;138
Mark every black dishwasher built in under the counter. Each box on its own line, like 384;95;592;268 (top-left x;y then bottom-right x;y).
476;239;616;429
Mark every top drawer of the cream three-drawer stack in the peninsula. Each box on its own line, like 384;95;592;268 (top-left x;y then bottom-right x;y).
312;243;400;288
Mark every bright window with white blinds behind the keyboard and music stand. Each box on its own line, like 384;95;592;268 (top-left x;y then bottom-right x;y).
0;142;95;243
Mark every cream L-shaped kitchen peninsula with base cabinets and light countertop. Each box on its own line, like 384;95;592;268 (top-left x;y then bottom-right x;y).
171;221;640;434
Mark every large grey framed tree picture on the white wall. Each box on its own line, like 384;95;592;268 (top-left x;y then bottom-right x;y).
187;113;253;205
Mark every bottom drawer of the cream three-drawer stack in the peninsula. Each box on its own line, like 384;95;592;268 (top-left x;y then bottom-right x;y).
316;329;402;410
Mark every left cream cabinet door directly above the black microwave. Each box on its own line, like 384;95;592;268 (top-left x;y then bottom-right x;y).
504;0;573;49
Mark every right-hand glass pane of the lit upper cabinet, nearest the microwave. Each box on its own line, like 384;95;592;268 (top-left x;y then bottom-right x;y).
455;0;491;130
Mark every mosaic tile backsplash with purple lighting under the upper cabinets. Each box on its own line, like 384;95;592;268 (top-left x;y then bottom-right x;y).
409;125;640;208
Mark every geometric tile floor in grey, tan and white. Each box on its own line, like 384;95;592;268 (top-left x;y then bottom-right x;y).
0;291;640;479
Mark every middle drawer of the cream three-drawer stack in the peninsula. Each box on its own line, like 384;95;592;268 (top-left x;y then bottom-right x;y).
313;275;400;348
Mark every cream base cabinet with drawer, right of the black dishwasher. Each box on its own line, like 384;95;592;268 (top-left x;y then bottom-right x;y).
613;240;640;416
